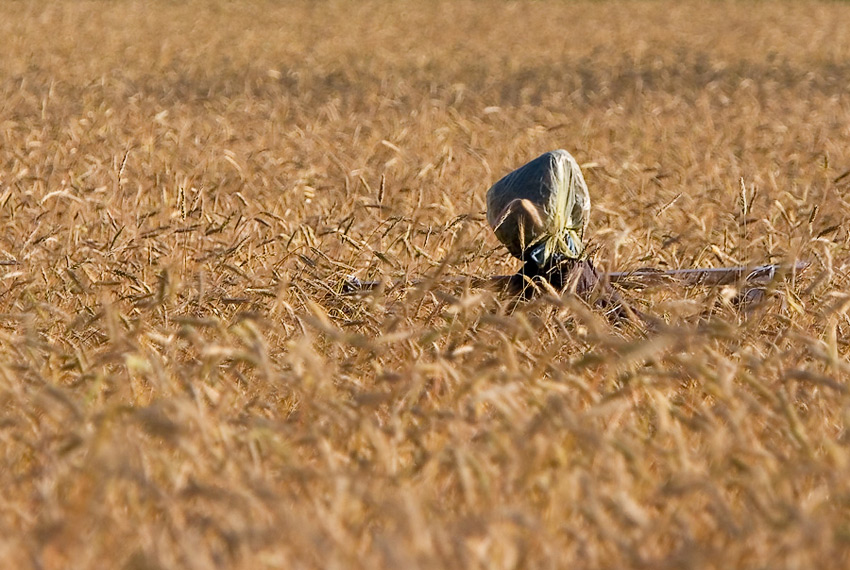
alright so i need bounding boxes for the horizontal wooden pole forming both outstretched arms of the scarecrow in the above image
[343,261,809,294]
